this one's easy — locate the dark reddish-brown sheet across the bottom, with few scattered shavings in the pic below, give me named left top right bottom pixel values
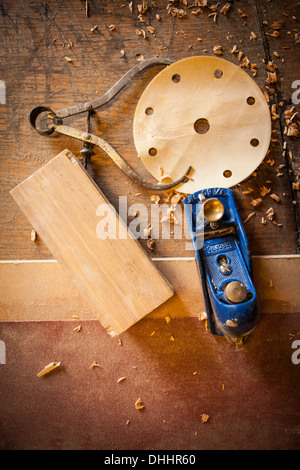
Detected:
left=0, top=314, right=300, bottom=450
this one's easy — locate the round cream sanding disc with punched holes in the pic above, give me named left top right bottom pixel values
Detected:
left=133, top=57, right=271, bottom=193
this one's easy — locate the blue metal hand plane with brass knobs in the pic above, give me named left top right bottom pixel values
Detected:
left=183, top=188, right=260, bottom=348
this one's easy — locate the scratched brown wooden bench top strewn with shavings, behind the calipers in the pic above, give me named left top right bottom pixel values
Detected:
left=0, top=0, right=300, bottom=259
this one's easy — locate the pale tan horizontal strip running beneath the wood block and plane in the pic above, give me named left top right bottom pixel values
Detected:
left=0, top=256, right=300, bottom=322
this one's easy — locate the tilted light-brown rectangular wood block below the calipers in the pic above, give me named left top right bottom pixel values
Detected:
left=11, top=150, right=173, bottom=335
